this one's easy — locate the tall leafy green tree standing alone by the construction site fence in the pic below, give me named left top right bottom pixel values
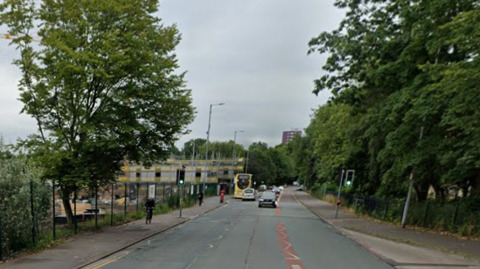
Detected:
left=0, top=0, right=194, bottom=220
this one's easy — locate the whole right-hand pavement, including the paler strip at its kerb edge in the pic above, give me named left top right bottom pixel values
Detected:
left=294, top=188, right=480, bottom=269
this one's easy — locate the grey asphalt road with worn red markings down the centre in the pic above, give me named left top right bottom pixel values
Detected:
left=88, top=189, right=391, bottom=269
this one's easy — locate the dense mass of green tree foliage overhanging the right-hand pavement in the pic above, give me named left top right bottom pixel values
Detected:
left=289, top=0, right=480, bottom=202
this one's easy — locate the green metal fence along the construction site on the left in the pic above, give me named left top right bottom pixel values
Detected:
left=0, top=182, right=218, bottom=260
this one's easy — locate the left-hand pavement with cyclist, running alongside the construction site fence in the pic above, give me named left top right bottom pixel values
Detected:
left=0, top=197, right=230, bottom=269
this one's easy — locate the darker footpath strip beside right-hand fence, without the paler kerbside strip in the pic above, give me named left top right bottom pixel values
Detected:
left=294, top=189, right=480, bottom=259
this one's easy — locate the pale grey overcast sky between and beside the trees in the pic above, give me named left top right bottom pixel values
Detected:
left=0, top=0, right=343, bottom=149
